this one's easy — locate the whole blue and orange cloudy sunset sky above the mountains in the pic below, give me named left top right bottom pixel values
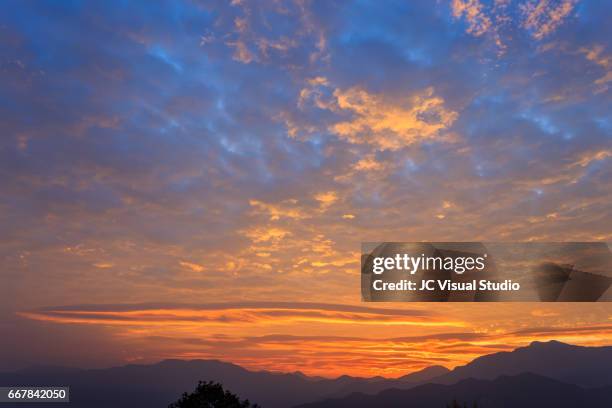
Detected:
left=0, top=0, right=612, bottom=377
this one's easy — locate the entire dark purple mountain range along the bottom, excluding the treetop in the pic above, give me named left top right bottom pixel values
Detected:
left=0, top=341, right=612, bottom=408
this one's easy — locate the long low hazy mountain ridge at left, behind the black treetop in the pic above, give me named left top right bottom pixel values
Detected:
left=0, top=360, right=440, bottom=408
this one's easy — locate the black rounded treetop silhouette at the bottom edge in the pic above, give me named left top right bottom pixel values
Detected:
left=168, top=381, right=260, bottom=408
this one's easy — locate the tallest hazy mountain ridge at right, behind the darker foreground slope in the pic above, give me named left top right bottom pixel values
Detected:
left=433, top=341, right=612, bottom=388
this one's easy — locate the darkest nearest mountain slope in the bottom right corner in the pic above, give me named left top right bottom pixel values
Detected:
left=296, top=373, right=612, bottom=408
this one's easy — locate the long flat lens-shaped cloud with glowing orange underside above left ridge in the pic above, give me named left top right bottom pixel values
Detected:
left=20, top=302, right=452, bottom=329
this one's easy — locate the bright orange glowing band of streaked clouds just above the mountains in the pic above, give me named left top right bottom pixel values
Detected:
left=21, top=302, right=612, bottom=377
